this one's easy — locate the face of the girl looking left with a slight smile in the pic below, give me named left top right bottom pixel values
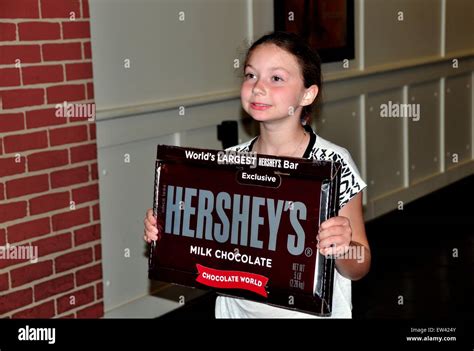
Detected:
left=240, top=44, right=317, bottom=122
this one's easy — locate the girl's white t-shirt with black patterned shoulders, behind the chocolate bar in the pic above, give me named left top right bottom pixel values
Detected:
left=215, top=125, right=367, bottom=318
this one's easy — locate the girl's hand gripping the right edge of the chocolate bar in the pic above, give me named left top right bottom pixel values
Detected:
left=316, top=216, right=352, bottom=257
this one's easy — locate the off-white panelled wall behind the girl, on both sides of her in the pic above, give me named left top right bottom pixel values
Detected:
left=90, top=0, right=474, bottom=316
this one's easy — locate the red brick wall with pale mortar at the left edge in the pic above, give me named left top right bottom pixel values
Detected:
left=0, top=0, right=103, bottom=318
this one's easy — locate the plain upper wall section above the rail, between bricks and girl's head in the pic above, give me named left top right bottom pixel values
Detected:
left=91, top=0, right=247, bottom=112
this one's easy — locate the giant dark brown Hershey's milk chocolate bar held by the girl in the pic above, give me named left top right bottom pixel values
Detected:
left=149, top=145, right=341, bottom=315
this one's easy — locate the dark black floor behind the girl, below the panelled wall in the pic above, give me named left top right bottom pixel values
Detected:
left=161, top=176, right=474, bottom=320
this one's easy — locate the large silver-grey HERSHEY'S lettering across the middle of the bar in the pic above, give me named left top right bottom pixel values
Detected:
left=165, top=185, right=307, bottom=256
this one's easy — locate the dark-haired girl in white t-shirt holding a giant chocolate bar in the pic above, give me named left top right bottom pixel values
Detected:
left=144, top=32, right=371, bottom=318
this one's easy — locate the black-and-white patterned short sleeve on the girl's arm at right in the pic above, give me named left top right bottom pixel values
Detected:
left=339, top=149, right=367, bottom=208
